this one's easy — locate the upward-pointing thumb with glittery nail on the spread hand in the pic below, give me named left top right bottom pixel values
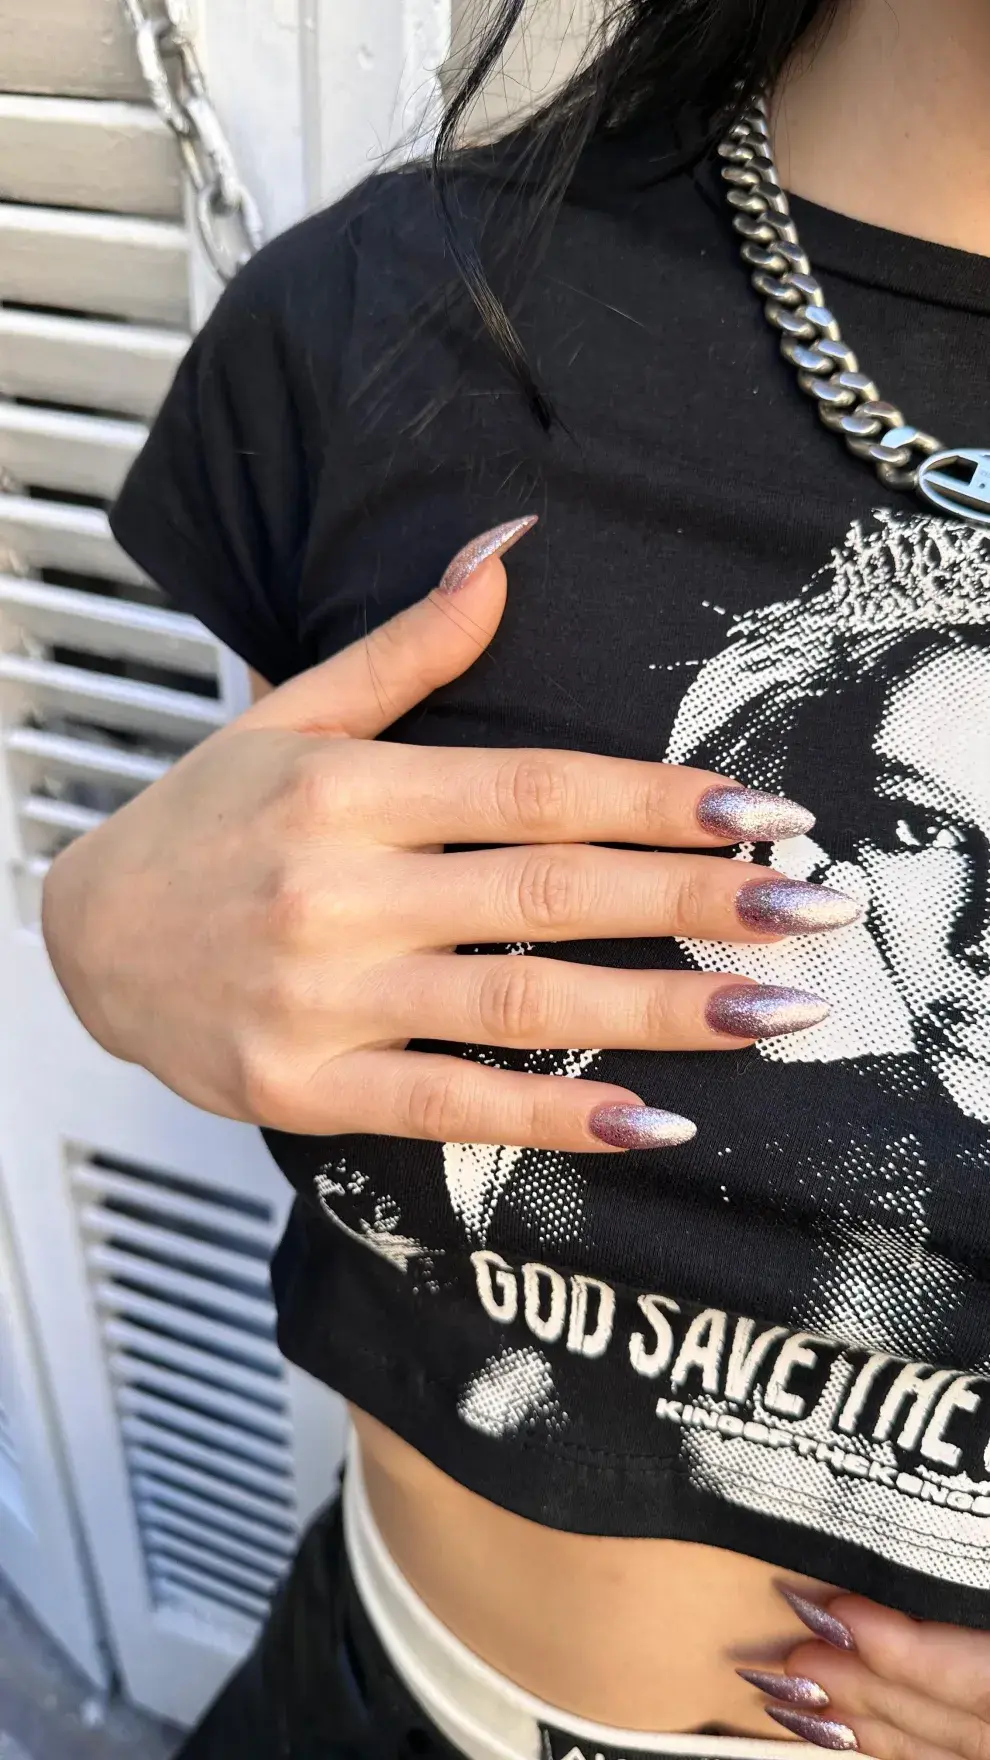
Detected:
left=234, top=514, right=537, bottom=739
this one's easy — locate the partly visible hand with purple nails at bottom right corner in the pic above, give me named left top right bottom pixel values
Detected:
left=740, top=1591, right=990, bottom=1760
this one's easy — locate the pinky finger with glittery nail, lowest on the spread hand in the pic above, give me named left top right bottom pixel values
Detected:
left=324, top=1051, right=696, bottom=1155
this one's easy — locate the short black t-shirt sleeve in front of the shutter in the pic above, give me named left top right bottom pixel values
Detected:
left=111, top=225, right=349, bottom=685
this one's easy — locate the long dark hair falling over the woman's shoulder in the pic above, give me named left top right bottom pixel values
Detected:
left=433, top=0, right=837, bottom=428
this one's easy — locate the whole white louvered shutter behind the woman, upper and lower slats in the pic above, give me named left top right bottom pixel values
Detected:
left=0, top=0, right=342, bottom=1721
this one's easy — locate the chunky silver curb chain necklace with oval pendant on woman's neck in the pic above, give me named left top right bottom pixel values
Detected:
left=719, top=99, right=990, bottom=526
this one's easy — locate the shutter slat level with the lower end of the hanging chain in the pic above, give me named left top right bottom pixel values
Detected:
left=0, top=202, right=188, bottom=327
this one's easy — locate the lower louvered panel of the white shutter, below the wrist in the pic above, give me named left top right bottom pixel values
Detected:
left=70, top=1153, right=298, bottom=1623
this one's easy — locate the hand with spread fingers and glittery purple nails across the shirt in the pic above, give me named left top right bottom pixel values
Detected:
left=44, top=521, right=860, bottom=1151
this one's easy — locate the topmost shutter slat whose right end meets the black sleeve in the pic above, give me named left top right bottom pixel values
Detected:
left=0, top=308, right=188, bottom=419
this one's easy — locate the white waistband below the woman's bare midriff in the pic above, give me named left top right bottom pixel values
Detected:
left=344, top=1443, right=821, bottom=1760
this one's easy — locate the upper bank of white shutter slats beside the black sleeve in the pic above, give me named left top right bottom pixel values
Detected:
left=0, top=75, right=225, bottom=924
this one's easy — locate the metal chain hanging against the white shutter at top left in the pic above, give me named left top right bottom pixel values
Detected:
left=122, top=0, right=262, bottom=282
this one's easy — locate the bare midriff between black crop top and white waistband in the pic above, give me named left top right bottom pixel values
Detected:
left=352, top=1410, right=821, bottom=1741
